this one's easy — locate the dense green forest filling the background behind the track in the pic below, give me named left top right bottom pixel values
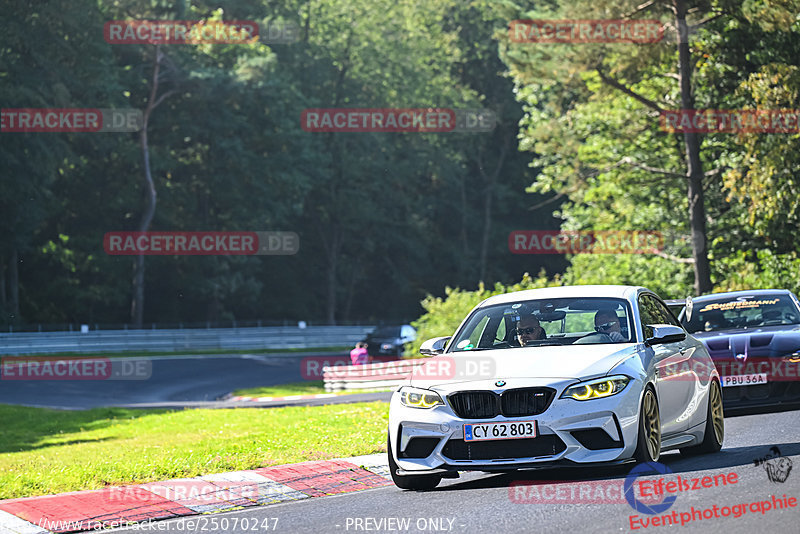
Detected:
left=0, top=0, right=800, bottom=330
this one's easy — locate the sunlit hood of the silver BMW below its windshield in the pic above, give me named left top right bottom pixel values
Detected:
left=409, top=343, right=637, bottom=388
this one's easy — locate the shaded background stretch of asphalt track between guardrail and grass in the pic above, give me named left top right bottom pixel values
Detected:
left=0, top=354, right=360, bottom=409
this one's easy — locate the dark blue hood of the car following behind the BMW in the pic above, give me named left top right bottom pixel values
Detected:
left=692, top=325, right=800, bottom=360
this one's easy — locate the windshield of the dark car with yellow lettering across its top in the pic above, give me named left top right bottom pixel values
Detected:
left=681, top=294, right=800, bottom=333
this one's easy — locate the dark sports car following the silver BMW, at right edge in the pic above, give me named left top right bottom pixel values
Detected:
left=679, top=289, right=800, bottom=409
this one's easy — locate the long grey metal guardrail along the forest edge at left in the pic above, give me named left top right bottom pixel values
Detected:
left=0, top=326, right=375, bottom=355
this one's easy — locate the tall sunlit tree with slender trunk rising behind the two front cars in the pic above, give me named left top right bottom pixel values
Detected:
left=502, top=0, right=791, bottom=294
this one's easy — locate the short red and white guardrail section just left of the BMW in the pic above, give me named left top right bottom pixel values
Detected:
left=322, top=358, right=427, bottom=391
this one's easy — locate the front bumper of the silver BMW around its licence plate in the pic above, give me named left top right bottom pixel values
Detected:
left=389, top=379, right=642, bottom=474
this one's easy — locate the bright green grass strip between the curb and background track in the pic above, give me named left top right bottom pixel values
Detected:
left=0, top=402, right=389, bottom=499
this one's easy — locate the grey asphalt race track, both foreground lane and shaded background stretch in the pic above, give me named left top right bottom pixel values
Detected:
left=0, top=355, right=800, bottom=534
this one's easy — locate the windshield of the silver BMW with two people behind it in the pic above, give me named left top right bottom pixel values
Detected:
left=452, top=298, right=633, bottom=352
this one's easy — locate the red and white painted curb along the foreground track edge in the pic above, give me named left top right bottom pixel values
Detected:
left=0, top=453, right=391, bottom=534
